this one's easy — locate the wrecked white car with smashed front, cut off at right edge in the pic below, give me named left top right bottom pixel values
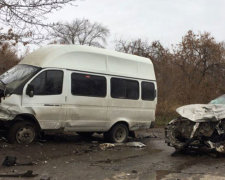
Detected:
left=165, top=95, right=225, bottom=153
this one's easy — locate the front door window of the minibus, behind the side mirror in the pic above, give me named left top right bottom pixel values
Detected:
left=30, top=70, right=63, bottom=95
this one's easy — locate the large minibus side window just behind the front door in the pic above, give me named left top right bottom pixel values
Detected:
left=71, top=73, right=106, bottom=97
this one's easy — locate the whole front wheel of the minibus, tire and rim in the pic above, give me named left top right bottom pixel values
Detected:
left=8, top=121, right=37, bottom=144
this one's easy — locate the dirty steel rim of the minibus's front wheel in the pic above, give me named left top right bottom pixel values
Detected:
left=16, top=127, right=35, bottom=144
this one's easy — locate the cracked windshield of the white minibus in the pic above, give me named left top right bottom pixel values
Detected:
left=0, top=64, right=39, bottom=93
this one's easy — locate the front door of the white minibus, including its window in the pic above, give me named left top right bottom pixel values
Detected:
left=22, top=69, right=66, bottom=129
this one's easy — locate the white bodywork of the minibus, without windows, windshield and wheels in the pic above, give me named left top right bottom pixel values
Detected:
left=0, top=45, right=157, bottom=132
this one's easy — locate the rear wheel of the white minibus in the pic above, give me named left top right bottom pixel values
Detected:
left=105, top=123, right=129, bottom=143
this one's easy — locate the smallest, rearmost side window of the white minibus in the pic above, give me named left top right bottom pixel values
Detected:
left=141, top=81, right=156, bottom=101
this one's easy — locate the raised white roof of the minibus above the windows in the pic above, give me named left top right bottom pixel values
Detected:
left=20, top=45, right=155, bottom=80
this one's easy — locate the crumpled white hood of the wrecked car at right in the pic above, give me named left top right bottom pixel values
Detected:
left=176, top=104, right=225, bottom=122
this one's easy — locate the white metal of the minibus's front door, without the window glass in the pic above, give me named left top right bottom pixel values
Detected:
left=22, top=68, right=67, bottom=129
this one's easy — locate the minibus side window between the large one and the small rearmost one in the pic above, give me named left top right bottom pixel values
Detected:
left=111, top=78, right=139, bottom=100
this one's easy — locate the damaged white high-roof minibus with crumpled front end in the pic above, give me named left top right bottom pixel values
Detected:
left=0, top=45, right=157, bottom=144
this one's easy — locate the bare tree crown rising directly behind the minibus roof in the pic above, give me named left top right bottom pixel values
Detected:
left=50, top=19, right=109, bottom=47
